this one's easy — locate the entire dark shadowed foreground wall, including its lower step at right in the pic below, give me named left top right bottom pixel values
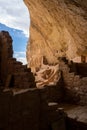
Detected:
left=0, top=88, right=65, bottom=130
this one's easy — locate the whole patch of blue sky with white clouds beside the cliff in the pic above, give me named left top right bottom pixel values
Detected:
left=0, top=0, right=30, bottom=64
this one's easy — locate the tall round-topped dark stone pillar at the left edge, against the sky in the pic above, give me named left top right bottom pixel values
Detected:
left=0, top=31, right=13, bottom=83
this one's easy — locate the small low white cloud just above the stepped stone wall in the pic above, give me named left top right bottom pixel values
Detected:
left=14, top=51, right=27, bottom=64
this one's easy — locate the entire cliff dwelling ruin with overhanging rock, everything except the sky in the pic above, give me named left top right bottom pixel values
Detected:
left=0, top=0, right=87, bottom=130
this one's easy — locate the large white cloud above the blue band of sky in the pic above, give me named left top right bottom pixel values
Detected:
left=0, top=0, right=30, bottom=37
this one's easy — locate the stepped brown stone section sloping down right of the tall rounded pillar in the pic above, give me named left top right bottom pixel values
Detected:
left=8, top=59, right=36, bottom=88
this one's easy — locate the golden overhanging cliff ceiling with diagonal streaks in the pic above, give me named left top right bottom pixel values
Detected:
left=24, top=0, right=87, bottom=87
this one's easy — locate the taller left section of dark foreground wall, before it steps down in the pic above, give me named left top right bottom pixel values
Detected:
left=0, top=89, right=47, bottom=130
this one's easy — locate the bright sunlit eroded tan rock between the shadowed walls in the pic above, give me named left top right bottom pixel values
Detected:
left=35, top=65, right=61, bottom=88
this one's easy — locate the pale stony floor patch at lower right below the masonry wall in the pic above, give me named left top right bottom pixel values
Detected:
left=59, top=104, right=87, bottom=124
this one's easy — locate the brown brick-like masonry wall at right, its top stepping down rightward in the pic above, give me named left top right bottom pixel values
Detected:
left=60, top=61, right=87, bottom=105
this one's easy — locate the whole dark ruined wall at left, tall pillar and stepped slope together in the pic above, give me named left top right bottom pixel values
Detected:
left=0, top=31, right=36, bottom=88
